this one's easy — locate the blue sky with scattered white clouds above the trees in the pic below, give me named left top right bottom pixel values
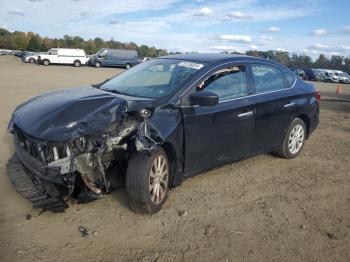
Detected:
left=0, top=0, right=350, bottom=57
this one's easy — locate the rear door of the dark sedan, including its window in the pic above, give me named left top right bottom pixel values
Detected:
left=251, top=63, right=297, bottom=153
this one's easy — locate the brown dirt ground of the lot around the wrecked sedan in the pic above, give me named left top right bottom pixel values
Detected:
left=0, top=57, right=350, bottom=261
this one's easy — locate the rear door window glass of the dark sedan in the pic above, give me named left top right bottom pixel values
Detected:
left=252, top=65, right=284, bottom=94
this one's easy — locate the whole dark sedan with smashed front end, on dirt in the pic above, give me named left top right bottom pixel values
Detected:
left=7, top=54, right=320, bottom=214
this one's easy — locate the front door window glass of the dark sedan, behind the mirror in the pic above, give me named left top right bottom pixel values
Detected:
left=197, top=65, right=248, bottom=101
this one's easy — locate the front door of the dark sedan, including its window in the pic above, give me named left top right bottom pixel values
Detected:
left=182, top=63, right=255, bottom=174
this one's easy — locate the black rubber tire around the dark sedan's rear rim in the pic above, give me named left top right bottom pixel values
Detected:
left=275, top=118, right=307, bottom=159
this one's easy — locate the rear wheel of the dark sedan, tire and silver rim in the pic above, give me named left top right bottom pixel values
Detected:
left=276, top=118, right=306, bottom=159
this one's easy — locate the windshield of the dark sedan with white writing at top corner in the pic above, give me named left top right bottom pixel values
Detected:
left=100, top=59, right=205, bottom=99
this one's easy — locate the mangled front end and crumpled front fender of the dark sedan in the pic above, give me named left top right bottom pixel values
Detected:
left=7, top=103, right=183, bottom=210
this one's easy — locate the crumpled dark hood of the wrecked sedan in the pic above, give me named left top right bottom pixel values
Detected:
left=10, top=87, right=152, bottom=141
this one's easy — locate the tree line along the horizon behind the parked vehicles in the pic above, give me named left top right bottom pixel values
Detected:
left=0, top=29, right=350, bottom=72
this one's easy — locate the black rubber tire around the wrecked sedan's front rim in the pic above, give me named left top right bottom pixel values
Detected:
left=126, top=148, right=171, bottom=215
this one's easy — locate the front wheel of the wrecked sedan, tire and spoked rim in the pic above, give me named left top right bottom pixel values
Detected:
left=126, top=148, right=170, bottom=214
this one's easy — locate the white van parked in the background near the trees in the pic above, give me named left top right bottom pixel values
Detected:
left=38, top=48, right=88, bottom=67
